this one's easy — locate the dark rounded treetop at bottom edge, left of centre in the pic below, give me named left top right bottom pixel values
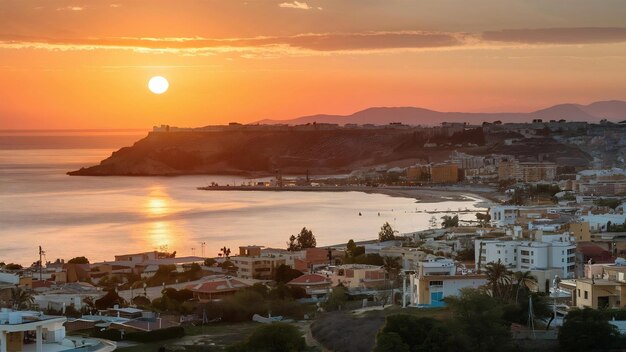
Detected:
left=227, top=323, right=306, bottom=352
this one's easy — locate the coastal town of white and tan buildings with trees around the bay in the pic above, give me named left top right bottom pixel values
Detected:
left=0, top=120, right=626, bottom=352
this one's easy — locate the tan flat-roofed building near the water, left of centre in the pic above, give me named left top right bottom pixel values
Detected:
left=230, top=246, right=287, bottom=280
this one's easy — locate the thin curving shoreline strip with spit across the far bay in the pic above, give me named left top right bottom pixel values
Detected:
left=198, top=186, right=499, bottom=207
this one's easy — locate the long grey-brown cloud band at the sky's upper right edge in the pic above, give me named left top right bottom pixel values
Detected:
left=482, top=27, right=626, bottom=44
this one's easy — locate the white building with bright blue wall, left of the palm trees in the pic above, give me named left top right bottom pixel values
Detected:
left=405, top=257, right=487, bottom=307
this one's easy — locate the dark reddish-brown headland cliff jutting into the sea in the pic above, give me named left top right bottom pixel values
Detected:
left=68, top=129, right=448, bottom=176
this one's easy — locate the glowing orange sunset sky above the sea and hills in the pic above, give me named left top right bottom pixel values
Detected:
left=0, top=0, right=626, bottom=129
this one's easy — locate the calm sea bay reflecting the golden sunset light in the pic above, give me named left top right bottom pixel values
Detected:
left=0, top=131, right=478, bottom=265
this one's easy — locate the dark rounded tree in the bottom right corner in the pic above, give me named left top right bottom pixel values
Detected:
left=559, top=308, right=624, bottom=352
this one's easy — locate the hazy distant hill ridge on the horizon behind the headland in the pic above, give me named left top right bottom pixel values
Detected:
left=256, top=100, right=626, bottom=125
